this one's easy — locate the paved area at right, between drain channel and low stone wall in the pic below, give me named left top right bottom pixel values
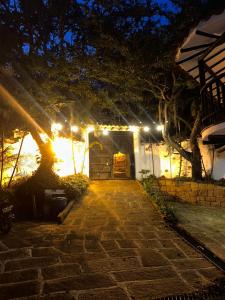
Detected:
left=173, top=202, right=225, bottom=261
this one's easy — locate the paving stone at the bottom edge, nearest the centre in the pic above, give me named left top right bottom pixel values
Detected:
left=78, top=288, right=129, bottom=300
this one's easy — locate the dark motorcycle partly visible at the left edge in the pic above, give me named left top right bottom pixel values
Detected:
left=0, top=199, right=15, bottom=234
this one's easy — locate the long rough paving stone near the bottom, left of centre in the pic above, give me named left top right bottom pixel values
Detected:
left=44, top=274, right=115, bottom=293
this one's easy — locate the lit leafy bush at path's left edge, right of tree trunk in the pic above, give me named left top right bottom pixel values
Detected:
left=60, top=174, right=89, bottom=200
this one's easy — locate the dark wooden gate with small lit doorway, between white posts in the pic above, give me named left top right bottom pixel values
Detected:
left=89, top=131, right=135, bottom=179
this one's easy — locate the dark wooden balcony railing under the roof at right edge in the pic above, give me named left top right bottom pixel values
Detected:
left=201, top=73, right=225, bottom=128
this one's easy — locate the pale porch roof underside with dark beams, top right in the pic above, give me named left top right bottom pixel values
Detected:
left=176, top=10, right=225, bottom=82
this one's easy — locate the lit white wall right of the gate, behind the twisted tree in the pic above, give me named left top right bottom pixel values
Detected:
left=134, top=133, right=225, bottom=180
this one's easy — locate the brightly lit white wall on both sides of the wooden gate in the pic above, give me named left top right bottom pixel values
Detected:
left=3, top=130, right=225, bottom=182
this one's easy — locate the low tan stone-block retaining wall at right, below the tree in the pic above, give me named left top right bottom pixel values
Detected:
left=159, top=179, right=225, bottom=207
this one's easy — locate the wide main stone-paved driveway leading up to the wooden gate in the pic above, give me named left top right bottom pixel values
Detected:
left=0, top=180, right=223, bottom=300
